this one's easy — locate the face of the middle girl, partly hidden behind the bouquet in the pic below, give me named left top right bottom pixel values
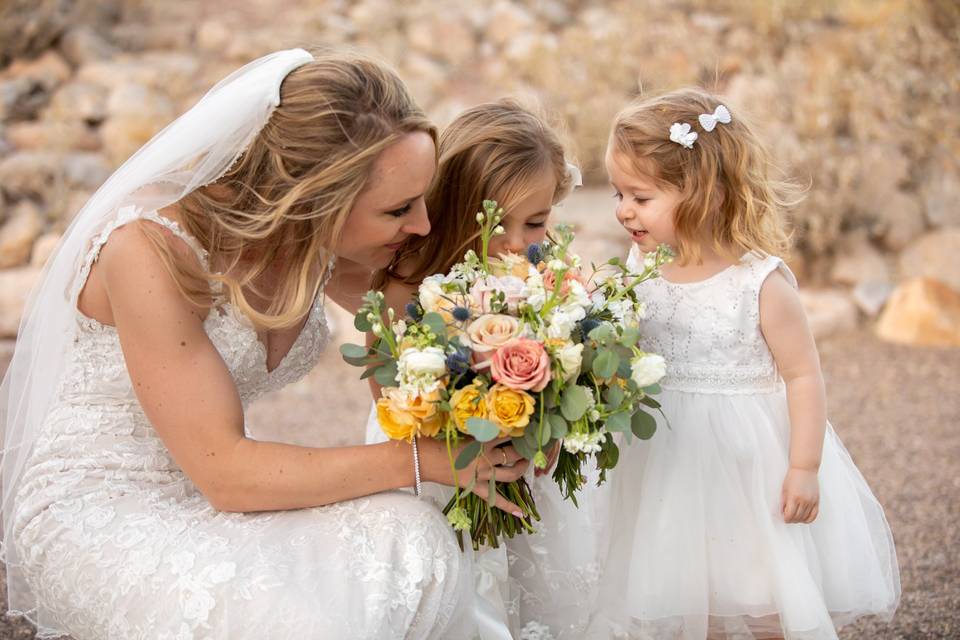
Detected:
left=489, top=167, right=557, bottom=256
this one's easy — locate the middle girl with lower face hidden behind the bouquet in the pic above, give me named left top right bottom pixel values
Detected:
left=367, top=100, right=598, bottom=638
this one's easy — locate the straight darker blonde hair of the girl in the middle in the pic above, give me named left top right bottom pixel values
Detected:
left=377, top=99, right=572, bottom=286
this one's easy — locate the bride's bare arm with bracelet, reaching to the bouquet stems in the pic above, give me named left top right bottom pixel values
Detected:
left=97, top=225, right=525, bottom=511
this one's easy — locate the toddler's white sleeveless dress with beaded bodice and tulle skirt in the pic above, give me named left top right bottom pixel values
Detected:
left=591, top=251, right=900, bottom=640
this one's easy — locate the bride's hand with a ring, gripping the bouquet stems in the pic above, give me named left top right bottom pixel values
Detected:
left=417, top=438, right=530, bottom=518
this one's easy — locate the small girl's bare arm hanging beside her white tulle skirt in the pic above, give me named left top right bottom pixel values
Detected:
left=760, top=271, right=827, bottom=523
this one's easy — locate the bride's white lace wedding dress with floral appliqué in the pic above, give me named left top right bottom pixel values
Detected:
left=12, top=207, right=475, bottom=640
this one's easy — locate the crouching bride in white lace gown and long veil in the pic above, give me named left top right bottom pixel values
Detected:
left=0, top=49, right=526, bottom=640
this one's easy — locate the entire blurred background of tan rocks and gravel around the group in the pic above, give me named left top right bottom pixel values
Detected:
left=0, top=0, right=960, bottom=638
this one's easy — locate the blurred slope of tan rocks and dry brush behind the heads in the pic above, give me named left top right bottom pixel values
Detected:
left=0, top=0, right=960, bottom=344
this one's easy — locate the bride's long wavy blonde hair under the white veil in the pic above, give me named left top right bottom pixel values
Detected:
left=144, top=52, right=437, bottom=329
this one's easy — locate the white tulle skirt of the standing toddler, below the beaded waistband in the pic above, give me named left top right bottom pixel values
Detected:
left=589, top=389, right=900, bottom=640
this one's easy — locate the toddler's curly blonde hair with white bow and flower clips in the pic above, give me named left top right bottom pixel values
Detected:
left=609, top=89, right=798, bottom=264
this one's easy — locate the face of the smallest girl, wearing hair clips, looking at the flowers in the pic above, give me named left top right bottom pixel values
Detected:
left=604, top=150, right=681, bottom=253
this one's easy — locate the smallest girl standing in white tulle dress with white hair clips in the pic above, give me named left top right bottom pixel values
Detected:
left=591, top=90, right=900, bottom=640
